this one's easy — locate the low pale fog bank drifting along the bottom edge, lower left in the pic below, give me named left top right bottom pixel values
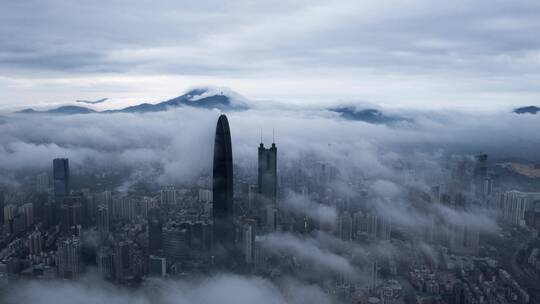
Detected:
left=0, top=274, right=332, bottom=304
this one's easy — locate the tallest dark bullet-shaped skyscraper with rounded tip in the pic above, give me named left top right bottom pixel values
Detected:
left=212, top=115, right=235, bottom=247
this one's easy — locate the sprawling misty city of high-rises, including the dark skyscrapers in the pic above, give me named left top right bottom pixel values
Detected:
left=0, top=107, right=540, bottom=303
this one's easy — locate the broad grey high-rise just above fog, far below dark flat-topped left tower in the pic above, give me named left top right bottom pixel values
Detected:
left=56, top=237, right=81, bottom=279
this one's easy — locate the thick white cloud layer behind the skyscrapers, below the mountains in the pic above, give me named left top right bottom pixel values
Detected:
left=0, top=107, right=540, bottom=183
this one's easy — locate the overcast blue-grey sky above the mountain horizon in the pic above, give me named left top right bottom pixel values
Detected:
left=0, top=0, right=540, bottom=110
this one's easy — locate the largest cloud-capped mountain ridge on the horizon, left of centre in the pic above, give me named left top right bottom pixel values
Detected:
left=17, top=88, right=248, bottom=114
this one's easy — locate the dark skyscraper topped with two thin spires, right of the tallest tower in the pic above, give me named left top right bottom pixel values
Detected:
left=258, top=143, right=277, bottom=206
